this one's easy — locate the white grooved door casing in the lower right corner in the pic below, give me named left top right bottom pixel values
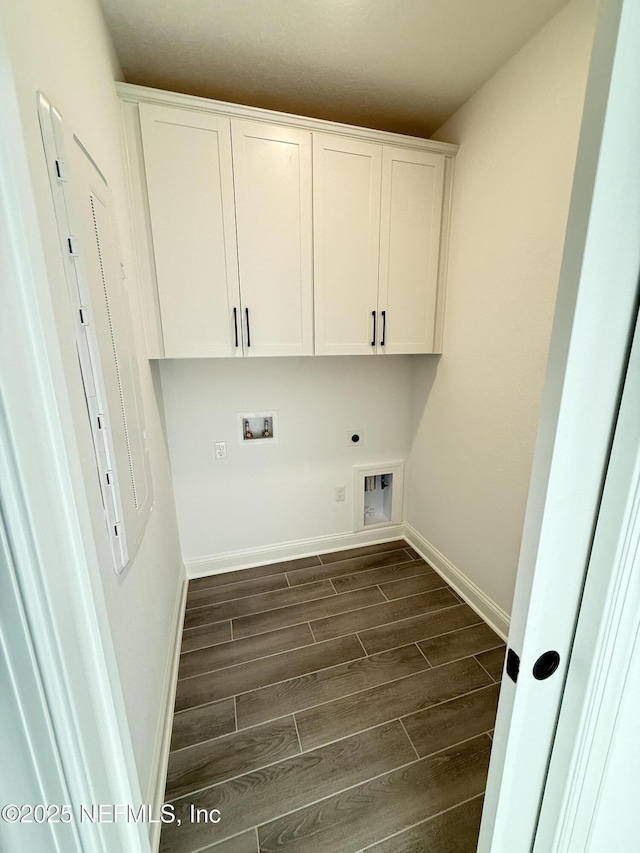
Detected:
left=534, top=278, right=640, bottom=853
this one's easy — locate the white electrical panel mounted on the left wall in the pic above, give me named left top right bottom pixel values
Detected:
left=38, top=93, right=153, bottom=574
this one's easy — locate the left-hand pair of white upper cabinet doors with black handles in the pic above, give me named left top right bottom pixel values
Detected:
left=140, top=109, right=313, bottom=358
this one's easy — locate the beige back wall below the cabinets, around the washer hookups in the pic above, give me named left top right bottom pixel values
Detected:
left=160, top=356, right=412, bottom=561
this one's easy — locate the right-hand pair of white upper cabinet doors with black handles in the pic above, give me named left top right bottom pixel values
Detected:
left=313, top=134, right=445, bottom=355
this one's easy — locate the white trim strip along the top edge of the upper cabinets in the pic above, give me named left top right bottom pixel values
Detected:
left=116, top=82, right=459, bottom=157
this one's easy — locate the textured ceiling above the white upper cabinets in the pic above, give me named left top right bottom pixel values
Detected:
left=101, top=0, right=567, bottom=136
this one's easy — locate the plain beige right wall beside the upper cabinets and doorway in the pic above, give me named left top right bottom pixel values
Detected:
left=407, top=0, right=594, bottom=613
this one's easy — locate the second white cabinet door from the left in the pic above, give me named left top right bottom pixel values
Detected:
left=231, top=120, right=313, bottom=356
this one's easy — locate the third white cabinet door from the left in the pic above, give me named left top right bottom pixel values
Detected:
left=313, top=134, right=382, bottom=355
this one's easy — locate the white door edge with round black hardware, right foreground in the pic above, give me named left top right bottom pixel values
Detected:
left=478, top=0, right=640, bottom=853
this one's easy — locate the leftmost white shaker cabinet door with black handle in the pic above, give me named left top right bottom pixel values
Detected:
left=140, top=104, right=242, bottom=358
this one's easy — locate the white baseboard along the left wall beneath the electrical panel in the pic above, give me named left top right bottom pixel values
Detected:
left=145, top=564, right=187, bottom=853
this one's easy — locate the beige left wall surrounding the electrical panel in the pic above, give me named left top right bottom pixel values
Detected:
left=0, top=0, right=183, bottom=802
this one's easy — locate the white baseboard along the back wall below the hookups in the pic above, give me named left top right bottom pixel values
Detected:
left=185, top=524, right=404, bottom=578
